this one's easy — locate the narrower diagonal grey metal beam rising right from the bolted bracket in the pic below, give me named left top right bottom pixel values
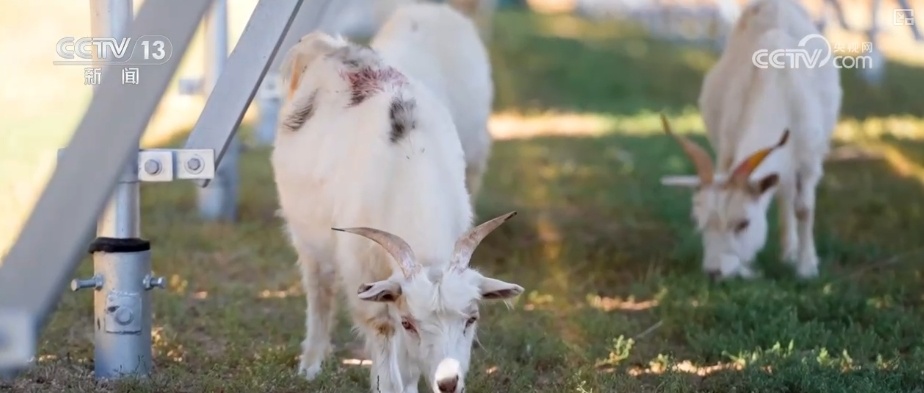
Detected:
left=184, top=0, right=304, bottom=187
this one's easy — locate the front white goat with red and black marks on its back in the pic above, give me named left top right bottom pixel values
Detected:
left=271, top=32, right=523, bottom=392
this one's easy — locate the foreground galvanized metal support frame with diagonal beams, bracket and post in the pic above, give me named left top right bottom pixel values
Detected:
left=0, top=0, right=303, bottom=378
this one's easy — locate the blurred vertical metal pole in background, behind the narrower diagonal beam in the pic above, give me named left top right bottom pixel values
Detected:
left=198, top=0, right=241, bottom=221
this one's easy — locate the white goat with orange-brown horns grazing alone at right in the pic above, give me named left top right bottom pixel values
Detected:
left=662, top=0, right=842, bottom=278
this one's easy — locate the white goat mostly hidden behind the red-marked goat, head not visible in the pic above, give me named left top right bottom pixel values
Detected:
left=369, top=3, right=494, bottom=206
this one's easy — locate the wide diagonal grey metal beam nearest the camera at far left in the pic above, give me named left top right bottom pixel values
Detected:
left=0, top=0, right=210, bottom=374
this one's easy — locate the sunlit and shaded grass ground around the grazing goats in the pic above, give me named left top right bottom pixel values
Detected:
left=9, top=7, right=924, bottom=393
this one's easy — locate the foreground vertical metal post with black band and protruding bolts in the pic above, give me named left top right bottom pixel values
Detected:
left=71, top=0, right=163, bottom=378
